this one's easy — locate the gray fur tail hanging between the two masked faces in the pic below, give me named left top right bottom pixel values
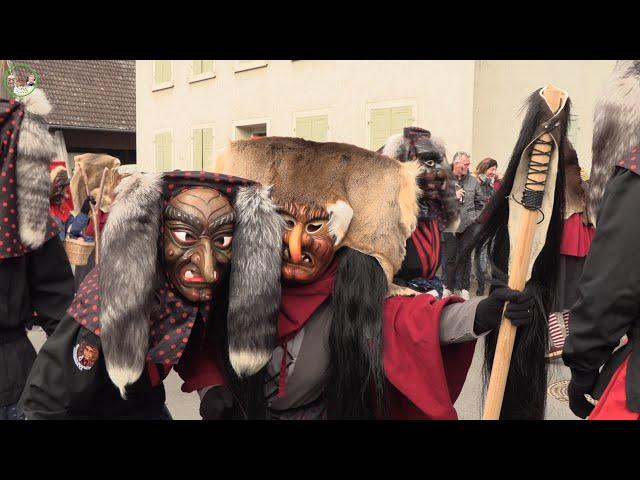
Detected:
left=227, top=186, right=284, bottom=377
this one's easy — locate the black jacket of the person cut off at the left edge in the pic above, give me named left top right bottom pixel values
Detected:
left=0, top=236, right=74, bottom=406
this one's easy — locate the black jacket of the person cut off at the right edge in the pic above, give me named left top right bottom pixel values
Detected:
left=562, top=168, right=640, bottom=411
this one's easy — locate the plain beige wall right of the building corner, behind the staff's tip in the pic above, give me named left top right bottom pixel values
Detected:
left=471, top=60, right=615, bottom=172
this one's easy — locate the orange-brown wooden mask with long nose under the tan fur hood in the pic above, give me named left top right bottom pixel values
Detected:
left=278, top=202, right=335, bottom=284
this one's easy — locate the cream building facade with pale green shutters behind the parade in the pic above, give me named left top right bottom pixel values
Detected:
left=136, top=60, right=615, bottom=175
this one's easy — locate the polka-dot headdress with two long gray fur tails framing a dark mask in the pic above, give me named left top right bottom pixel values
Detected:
left=99, top=171, right=283, bottom=392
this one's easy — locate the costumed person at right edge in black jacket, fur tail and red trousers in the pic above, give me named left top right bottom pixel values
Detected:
left=562, top=60, right=640, bottom=420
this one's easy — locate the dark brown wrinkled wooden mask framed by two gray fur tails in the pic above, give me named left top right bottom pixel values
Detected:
left=162, top=188, right=235, bottom=302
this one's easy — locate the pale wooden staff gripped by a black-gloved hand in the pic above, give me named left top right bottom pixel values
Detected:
left=482, top=85, right=562, bottom=420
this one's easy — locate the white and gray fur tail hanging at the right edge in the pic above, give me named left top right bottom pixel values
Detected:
left=586, top=60, right=640, bottom=225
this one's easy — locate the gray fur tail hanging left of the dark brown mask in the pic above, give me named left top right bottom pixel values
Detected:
left=100, top=173, right=162, bottom=398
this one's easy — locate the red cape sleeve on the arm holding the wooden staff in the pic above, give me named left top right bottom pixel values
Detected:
left=384, top=294, right=475, bottom=420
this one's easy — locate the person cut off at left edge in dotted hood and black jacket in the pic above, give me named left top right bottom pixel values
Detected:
left=0, top=90, right=73, bottom=420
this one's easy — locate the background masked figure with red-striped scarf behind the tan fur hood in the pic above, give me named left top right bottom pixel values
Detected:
left=378, top=127, right=460, bottom=297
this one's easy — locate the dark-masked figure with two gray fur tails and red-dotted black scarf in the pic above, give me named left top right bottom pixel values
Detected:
left=20, top=171, right=282, bottom=419
